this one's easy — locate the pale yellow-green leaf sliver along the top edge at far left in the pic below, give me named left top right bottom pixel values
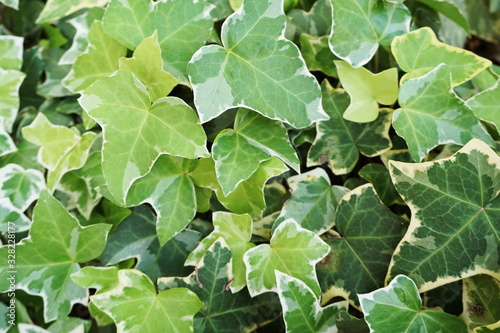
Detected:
left=35, top=0, right=109, bottom=24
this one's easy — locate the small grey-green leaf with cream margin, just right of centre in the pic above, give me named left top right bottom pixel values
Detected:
left=273, top=168, right=348, bottom=235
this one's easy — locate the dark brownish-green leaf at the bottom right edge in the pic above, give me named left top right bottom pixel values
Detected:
left=461, top=274, right=500, bottom=329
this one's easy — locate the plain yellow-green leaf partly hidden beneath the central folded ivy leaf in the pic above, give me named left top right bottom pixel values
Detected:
left=215, top=157, right=288, bottom=219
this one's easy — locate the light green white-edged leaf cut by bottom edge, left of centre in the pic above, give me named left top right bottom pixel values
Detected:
left=90, top=270, right=203, bottom=333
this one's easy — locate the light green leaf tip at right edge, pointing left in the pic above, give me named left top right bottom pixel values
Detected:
left=465, top=80, right=500, bottom=133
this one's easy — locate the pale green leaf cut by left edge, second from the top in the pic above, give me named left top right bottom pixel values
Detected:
left=0, top=68, right=26, bottom=133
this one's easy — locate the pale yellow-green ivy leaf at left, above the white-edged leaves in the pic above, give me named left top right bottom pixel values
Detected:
left=22, top=113, right=96, bottom=191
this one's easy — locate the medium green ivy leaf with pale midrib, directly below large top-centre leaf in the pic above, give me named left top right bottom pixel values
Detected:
left=212, top=108, right=300, bottom=195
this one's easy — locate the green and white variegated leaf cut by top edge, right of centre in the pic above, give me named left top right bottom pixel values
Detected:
left=330, top=0, right=411, bottom=68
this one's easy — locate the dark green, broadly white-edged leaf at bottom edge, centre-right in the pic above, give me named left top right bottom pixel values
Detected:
left=276, top=271, right=348, bottom=333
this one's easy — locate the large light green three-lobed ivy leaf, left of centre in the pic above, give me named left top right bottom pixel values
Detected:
left=78, top=70, right=208, bottom=204
